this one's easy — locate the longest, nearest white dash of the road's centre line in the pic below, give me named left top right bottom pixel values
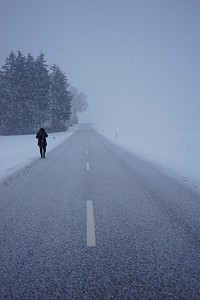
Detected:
left=87, top=200, right=96, bottom=247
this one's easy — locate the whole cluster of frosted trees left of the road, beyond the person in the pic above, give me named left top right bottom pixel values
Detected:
left=0, top=51, right=89, bottom=135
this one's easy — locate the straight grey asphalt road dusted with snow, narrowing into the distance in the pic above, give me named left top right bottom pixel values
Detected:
left=0, top=125, right=200, bottom=300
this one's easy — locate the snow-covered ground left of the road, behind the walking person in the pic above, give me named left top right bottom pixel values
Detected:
left=0, top=127, right=76, bottom=180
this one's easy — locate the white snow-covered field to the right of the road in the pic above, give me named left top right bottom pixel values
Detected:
left=94, top=123, right=200, bottom=192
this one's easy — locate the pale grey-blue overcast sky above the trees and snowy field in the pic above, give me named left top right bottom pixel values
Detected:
left=0, top=0, right=200, bottom=130
